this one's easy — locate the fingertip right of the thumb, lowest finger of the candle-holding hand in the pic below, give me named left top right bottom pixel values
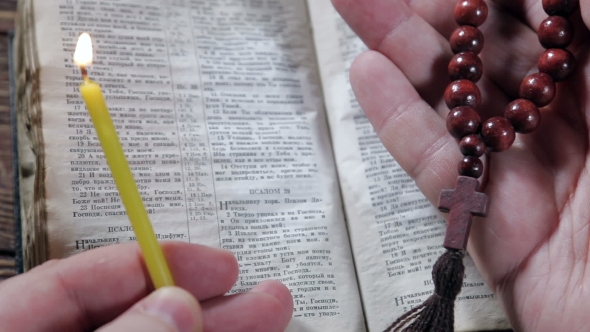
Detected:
left=201, top=280, right=293, bottom=332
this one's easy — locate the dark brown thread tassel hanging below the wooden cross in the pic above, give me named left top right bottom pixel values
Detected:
left=384, top=249, right=465, bottom=332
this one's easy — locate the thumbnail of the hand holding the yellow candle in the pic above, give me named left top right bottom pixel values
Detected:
left=137, top=287, right=201, bottom=332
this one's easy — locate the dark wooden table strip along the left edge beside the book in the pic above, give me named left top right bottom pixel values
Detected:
left=0, top=0, right=17, bottom=280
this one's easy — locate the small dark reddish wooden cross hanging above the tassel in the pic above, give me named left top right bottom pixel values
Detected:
left=438, top=176, right=489, bottom=250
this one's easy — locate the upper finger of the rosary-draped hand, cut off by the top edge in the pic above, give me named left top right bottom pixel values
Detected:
left=333, top=0, right=508, bottom=117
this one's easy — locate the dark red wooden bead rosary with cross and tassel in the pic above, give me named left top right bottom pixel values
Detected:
left=385, top=0, right=578, bottom=332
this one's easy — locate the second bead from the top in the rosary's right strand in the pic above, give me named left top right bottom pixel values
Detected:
left=537, top=16, right=574, bottom=48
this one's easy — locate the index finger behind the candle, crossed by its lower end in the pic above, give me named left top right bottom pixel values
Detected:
left=0, top=242, right=238, bottom=331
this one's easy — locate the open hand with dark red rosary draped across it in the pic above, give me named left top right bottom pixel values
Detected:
left=333, top=0, right=590, bottom=331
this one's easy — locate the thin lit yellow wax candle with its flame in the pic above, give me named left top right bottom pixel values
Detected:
left=74, top=34, right=174, bottom=288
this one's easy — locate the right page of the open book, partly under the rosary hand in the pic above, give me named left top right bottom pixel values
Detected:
left=309, top=0, right=508, bottom=331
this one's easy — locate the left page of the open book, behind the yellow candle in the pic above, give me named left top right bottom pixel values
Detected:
left=28, top=0, right=365, bottom=331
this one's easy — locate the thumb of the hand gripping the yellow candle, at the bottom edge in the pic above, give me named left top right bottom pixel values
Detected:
left=98, top=287, right=203, bottom=332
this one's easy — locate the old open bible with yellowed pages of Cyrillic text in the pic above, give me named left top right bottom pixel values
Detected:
left=15, top=0, right=509, bottom=331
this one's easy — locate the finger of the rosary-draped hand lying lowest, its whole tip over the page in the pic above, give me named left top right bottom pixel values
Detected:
left=351, top=51, right=460, bottom=201
